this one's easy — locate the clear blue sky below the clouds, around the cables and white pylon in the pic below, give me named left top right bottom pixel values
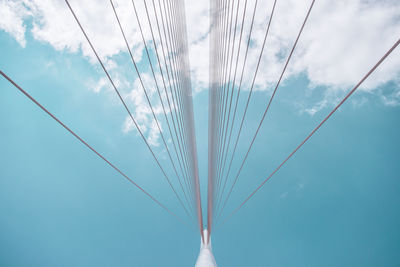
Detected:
left=0, top=1, right=400, bottom=266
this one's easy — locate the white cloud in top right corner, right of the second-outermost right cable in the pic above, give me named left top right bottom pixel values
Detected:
left=292, top=1, right=400, bottom=91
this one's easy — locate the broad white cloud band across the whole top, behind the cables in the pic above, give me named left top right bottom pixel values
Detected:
left=0, top=0, right=400, bottom=116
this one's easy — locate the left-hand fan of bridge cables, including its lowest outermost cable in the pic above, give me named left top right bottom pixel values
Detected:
left=1, top=0, right=203, bottom=232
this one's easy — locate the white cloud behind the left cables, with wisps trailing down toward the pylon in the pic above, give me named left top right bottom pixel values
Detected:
left=0, top=0, right=176, bottom=146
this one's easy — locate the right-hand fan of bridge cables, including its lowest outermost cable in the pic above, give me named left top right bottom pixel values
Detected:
left=207, top=0, right=398, bottom=234
